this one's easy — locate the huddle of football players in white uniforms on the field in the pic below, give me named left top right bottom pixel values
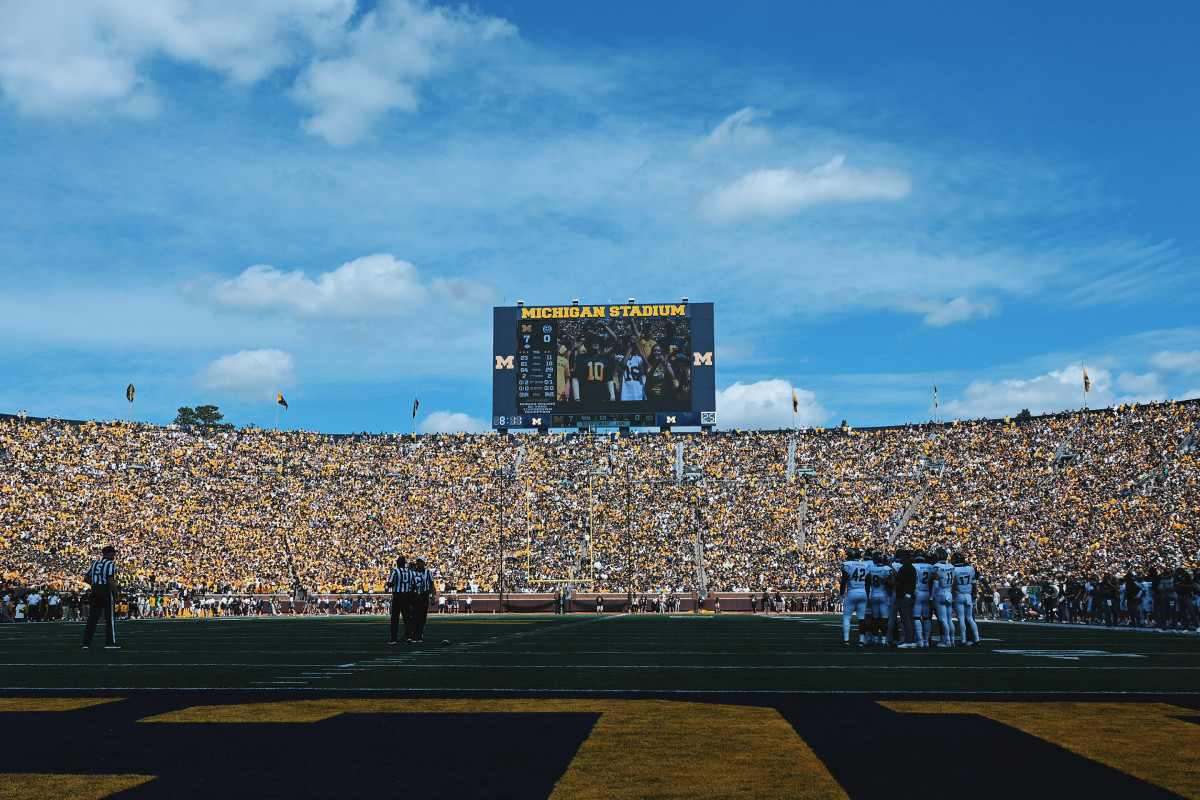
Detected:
left=839, top=548, right=979, bottom=648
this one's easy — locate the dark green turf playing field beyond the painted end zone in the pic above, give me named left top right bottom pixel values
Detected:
left=0, top=614, right=1200, bottom=693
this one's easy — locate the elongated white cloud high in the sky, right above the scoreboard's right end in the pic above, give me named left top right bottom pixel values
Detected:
left=700, top=156, right=912, bottom=224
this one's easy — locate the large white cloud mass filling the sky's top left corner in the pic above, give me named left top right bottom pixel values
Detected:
left=0, top=0, right=514, bottom=145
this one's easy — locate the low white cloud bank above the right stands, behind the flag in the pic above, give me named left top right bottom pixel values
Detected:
left=930, top=363, right=1165, bottom=419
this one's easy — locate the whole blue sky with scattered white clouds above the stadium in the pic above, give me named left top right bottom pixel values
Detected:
left=0, top=0, right=1200, bottom=432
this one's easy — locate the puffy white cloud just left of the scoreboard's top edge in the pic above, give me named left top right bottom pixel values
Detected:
left=208, top=253, right=491, bottom=319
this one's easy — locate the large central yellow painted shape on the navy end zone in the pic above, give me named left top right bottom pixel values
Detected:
left=142, top=698, right=847, bottom=800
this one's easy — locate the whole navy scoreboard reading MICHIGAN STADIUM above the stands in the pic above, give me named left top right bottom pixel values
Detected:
left=492, top=301, right=716, bottom=429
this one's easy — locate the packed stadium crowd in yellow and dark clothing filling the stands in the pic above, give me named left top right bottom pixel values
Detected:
left=0, top=401, right=1200, bottom=616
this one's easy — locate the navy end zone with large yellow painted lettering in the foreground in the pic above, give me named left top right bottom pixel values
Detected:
left=0, top=691, right=1200, bottom=800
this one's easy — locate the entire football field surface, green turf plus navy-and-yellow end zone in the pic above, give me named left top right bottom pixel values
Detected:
left=0, top=614, right=1200, bottom=800
